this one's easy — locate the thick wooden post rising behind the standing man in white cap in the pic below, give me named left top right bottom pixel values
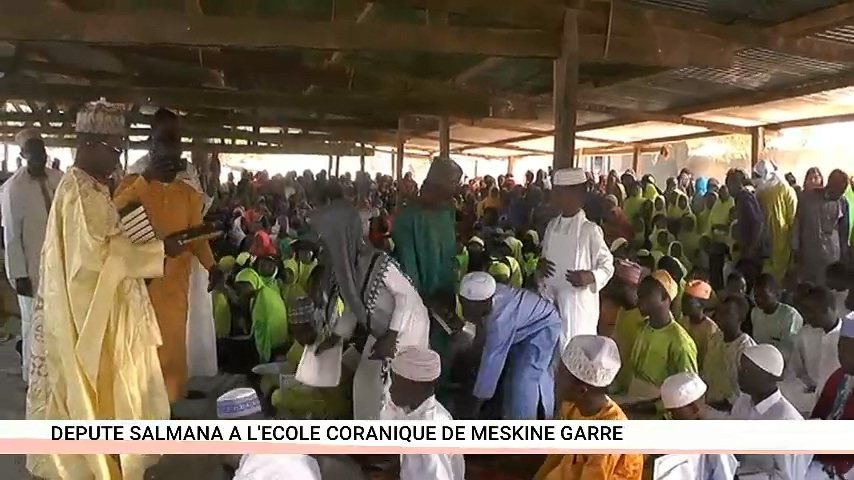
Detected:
left=553, top=9, right=578, bottom=169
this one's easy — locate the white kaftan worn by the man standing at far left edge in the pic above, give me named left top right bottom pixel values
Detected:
left=0, top=167, right=62, bottom=382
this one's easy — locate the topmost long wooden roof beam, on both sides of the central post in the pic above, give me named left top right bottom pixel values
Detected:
left=0, top=11, right=732, bottom=66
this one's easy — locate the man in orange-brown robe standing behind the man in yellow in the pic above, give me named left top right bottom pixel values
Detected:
left=113, top=109, right=215, bottom=402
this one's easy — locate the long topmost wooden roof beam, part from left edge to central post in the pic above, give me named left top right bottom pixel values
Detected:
left=0, top=9, right=558, bottom=57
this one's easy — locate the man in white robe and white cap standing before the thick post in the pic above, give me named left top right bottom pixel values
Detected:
left=538, top=168, right=614, bottom=351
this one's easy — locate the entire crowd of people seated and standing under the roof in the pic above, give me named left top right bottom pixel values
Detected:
left=0, top=98, right=854, bottom=480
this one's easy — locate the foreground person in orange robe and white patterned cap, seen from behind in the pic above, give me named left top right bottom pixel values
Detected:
left=534, top=335, right=643, bottom=480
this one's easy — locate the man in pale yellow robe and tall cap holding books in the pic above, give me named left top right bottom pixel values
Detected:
left=26, top=103, right=176, bottom=480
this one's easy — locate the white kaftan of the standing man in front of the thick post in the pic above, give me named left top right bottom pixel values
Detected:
left=540, top=210, right=614, bottom=351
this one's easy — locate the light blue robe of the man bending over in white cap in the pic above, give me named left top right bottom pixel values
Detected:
left=472, top=285, right=561, bottom=420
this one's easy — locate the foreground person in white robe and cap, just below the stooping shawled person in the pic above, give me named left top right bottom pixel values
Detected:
left=381, top=347, right=465, bottom=480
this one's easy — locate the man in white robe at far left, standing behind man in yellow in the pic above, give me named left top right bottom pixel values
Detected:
left=0, top=130, right=62, bottom=382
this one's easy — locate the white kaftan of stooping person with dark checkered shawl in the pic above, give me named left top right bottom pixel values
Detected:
left=353, top=263, right=430, bottom=420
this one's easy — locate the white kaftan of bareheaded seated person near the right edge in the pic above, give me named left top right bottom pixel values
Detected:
left=780, top=322, right=842, bottom=414
